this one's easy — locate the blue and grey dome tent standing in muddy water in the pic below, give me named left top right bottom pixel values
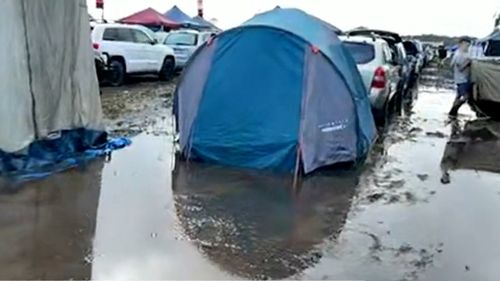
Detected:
left=174, top=9, right=376, bottom=173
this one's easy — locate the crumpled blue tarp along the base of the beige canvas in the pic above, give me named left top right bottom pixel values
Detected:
left=0, top=129, right=131, bottom=181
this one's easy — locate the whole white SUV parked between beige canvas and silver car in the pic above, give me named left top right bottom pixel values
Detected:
left=92, top=24, right=176, bottom=86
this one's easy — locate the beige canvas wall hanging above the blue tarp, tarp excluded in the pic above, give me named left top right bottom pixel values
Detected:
left=0, top=0, right=104, bottom=152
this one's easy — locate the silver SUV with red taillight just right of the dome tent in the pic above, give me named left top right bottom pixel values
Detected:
left=340, top=36, right=401, bottom=125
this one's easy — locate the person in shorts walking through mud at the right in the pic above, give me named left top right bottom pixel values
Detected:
left=449, top=38, right=472, bottom=117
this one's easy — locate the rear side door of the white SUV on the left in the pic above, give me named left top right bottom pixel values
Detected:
left=118, top=27, right=147, bottom=72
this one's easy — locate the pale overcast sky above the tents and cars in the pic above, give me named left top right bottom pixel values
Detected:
left=87, top=0, right=500, bottom=37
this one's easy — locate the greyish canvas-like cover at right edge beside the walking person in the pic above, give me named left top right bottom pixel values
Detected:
left=471, top=59, right=500, bottom=117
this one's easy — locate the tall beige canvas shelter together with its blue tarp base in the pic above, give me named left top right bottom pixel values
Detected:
left=0, top=0, right=129, bottom=179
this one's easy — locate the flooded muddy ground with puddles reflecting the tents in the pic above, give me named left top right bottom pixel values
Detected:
left=0, top=67, right=500, bottom=281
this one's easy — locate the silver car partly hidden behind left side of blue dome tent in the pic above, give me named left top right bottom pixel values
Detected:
left=163, top=29, right=214, bottom=69
